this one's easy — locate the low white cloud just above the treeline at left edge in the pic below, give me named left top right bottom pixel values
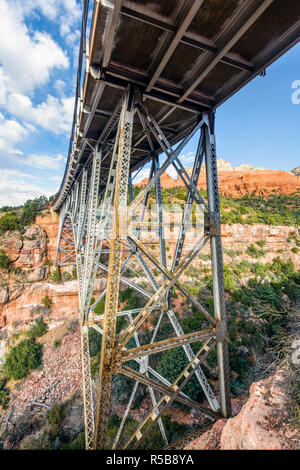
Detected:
left=0, top=168, right=53, bottom=207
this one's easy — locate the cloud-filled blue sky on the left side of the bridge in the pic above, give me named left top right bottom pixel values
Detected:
left=0, top=0, right=81, bottom=207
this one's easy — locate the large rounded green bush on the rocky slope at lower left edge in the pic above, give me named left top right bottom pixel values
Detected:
left=4, top=339, right=42, bottom=380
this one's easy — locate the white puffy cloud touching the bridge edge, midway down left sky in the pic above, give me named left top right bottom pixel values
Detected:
left=6, top=93, right=74, bottom=134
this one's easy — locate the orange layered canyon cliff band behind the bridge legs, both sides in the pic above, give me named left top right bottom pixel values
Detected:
left=0, top=213, right=300, bottom=328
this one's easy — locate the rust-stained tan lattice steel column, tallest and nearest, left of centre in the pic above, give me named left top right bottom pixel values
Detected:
left=94, top=93, right=134, bottom=449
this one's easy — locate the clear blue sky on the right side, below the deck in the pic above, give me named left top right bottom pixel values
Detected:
left=172, top=39, right=300, bottom=174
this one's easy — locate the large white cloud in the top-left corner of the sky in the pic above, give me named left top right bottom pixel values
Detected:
left=0, top=0, right=69, bottom=93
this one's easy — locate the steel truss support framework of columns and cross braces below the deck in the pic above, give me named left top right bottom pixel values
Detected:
left=57, top=88, right=231, bottom=449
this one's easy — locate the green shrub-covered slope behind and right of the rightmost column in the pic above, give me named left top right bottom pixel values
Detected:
left=157, top=253, right=300, bottom=400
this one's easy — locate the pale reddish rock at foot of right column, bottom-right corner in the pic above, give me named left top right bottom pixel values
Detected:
left=185, top=371, right=300, bottom=450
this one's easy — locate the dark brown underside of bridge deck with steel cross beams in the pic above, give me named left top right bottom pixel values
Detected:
left=55, top=0, right=300, bottom=210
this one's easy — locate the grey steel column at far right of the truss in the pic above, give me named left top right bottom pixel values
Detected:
left=203, top=114, right=231, bottom=418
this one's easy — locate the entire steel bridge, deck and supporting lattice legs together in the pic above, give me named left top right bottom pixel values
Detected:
left=53, top=0, right=300, bottom=449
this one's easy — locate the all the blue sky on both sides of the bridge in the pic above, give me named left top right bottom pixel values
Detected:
left=0, top=0, right=300, bottom=207
